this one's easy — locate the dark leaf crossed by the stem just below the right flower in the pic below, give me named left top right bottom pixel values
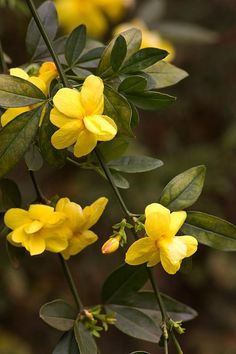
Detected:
left=116, top=291, right=197, bottom=322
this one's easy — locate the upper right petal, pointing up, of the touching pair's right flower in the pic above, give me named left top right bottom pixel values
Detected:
left=83, top=197, right=108, bottom=229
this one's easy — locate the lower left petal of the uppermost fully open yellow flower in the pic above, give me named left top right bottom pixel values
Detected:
left=51, top=120, right=82, bottom=149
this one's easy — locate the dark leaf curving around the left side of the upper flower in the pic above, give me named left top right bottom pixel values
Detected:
left=39, top=107, right=67, bottom=168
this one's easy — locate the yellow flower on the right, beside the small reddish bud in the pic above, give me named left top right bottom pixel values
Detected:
left=125, top=203, right=198, bottom=274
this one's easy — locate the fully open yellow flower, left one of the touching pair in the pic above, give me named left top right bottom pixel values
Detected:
left=4, top=204, right=71, bottom=256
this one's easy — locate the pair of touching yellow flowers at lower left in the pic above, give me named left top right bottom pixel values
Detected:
left=4, top=197, right=108, bottom=259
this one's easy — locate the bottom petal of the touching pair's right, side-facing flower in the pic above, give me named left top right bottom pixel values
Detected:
left=62, top=230, right=98, bottom=259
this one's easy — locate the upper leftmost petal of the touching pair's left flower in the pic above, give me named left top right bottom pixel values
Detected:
left=4, top=208, right=32, bottom=230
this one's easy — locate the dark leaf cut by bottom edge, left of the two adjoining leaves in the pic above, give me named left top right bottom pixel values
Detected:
left=52, top=330, right=80, bottom=354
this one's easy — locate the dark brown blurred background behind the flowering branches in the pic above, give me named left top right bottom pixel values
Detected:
left=0, top=0, right=236, bottom=354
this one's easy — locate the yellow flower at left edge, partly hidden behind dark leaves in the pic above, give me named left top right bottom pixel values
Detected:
left=1, top=62, right=57, bottom=127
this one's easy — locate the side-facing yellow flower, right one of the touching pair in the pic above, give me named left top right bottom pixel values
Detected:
left=56, top=197, right=108, bottom=259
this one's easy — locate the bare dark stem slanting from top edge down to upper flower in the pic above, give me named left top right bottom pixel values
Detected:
left=26, top=0, right=70, bottom=87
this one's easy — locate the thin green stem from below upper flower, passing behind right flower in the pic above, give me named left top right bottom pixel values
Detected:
left=95, top=148, right=168, bottom=354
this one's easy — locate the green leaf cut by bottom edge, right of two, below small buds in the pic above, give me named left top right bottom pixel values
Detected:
left=74, top=320, right=97, bottom=354
